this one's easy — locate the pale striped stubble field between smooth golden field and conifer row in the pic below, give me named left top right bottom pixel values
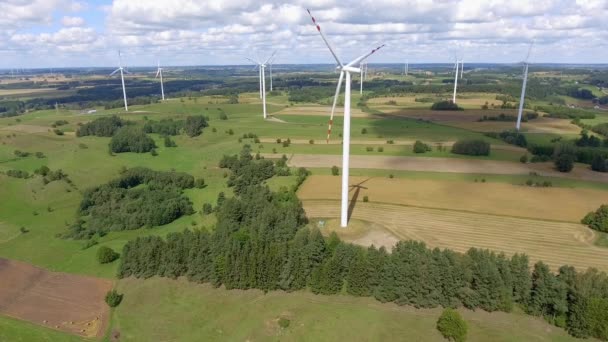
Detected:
left=303, top=200, right=608, bottom=271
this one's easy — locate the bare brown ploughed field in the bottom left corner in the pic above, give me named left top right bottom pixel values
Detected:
left=0, top=258, right=112, bottom=337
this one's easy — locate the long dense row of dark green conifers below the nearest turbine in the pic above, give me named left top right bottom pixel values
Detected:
left=118, top=184, right=608, bottom=339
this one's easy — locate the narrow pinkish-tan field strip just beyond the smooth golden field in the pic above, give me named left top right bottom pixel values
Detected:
left=284, top=154, right=608, bottom=183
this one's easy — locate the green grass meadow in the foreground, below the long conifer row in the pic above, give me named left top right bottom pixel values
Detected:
left=111, top=278, right=573, bottom=341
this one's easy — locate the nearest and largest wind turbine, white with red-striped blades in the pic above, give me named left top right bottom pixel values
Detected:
left=307, top=10, right=384, bottom=228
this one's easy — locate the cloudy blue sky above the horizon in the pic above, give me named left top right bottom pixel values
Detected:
left=0, top=0, right=608, bottom=69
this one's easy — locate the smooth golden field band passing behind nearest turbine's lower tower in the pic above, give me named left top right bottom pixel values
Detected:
left=298, top=175, right=608, bottom=222
